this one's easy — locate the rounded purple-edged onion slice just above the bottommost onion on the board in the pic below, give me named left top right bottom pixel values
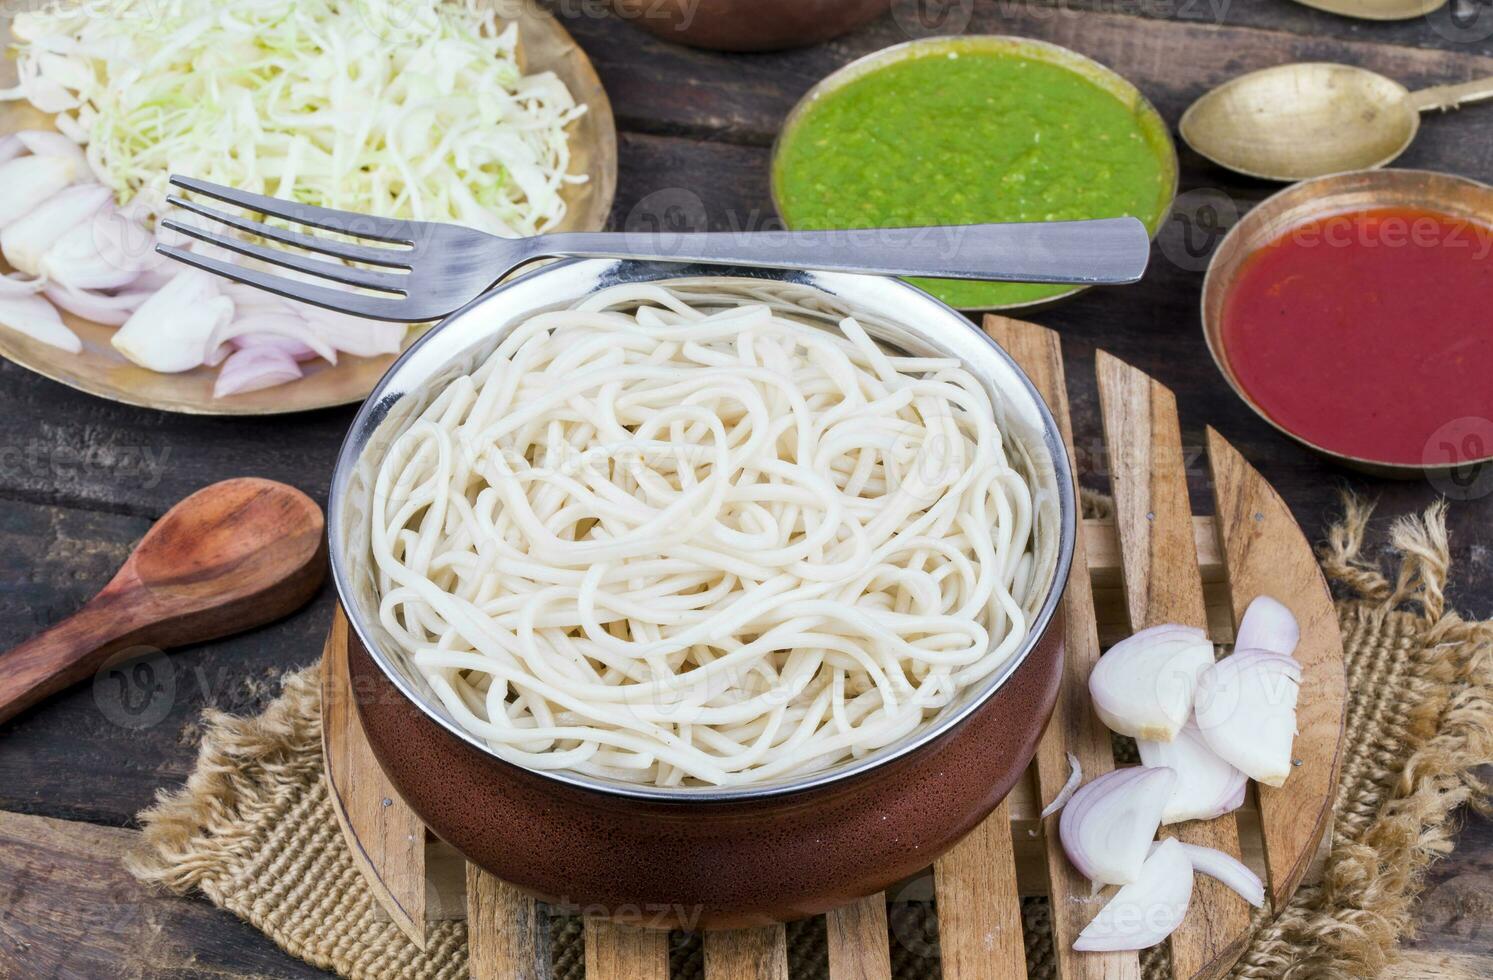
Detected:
left=1059, top=766, right=1176, bottom=884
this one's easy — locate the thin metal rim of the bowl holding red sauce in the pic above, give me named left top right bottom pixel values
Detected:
left=1197, top=167, right=1493, bottom=477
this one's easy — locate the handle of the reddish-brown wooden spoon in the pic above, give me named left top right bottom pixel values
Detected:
left=0, top=589, right=142, bottom=722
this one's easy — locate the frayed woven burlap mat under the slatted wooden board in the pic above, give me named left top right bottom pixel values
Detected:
left=130, top=502, right=1493, bottom=980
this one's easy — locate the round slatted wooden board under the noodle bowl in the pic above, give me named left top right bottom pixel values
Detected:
left=322, top=317, right=1345, bottom=980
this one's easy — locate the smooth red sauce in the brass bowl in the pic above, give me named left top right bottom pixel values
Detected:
left=1223, top=208, right=1493, bottom=465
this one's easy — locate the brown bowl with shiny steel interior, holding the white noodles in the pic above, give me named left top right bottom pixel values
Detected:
left=328, top=260, right=1076, bottom=928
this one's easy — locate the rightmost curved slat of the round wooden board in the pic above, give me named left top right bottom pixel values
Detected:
left=1208, top=429, right=1347, bottom=908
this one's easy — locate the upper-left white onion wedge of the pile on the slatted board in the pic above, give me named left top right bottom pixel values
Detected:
left=1088, top=626, right=1214, bottom=741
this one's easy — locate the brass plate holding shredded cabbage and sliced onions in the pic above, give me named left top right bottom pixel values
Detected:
left=0, top=0, right=617, bottom=415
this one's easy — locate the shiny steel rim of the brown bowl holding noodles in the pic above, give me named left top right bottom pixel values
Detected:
left=327, top=258, right=1078, bottom=804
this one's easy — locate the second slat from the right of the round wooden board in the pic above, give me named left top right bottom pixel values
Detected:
left=1097, top=351, right=1250, bottom=980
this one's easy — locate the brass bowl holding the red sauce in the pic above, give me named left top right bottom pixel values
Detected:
left=1202, top=169, right=1493, bottom=480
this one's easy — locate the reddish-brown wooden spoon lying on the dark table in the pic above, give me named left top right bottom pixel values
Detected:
left=0, top=478, right=327, bottom=722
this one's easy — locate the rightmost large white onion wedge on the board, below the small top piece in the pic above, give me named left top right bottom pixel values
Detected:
left=1196, top=650, right=1302, bottom=786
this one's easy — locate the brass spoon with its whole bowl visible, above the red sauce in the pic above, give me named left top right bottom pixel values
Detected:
left=1178, top=63, right=1493, bottom=181
